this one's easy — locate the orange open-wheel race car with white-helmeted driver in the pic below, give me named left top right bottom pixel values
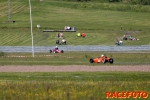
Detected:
left=90, top=54, right=114, bottom=64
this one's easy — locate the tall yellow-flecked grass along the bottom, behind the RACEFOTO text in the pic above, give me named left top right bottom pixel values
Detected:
left=0, top=81, right=149, bottom=100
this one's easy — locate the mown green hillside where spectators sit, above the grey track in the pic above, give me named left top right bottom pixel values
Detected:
left=0, top=0, right=150, bottom=46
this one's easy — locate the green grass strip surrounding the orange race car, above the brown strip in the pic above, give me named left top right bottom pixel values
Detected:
left=0, top=52, right=150, bottom=66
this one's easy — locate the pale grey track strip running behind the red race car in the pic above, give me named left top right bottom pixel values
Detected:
left=0, top=45, right=150, bottom=52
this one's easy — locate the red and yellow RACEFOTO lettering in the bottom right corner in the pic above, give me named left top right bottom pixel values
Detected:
left=106, top=91, right=148, bottom=99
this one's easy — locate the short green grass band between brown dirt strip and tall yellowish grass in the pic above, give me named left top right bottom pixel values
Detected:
left=0, top=72, right=150, bottom=82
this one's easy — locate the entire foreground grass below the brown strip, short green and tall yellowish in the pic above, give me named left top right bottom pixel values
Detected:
left=0, top=72, right=150, bottom=100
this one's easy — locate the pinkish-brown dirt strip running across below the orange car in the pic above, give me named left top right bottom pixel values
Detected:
left=0, top=65, right=150, bottom=72
